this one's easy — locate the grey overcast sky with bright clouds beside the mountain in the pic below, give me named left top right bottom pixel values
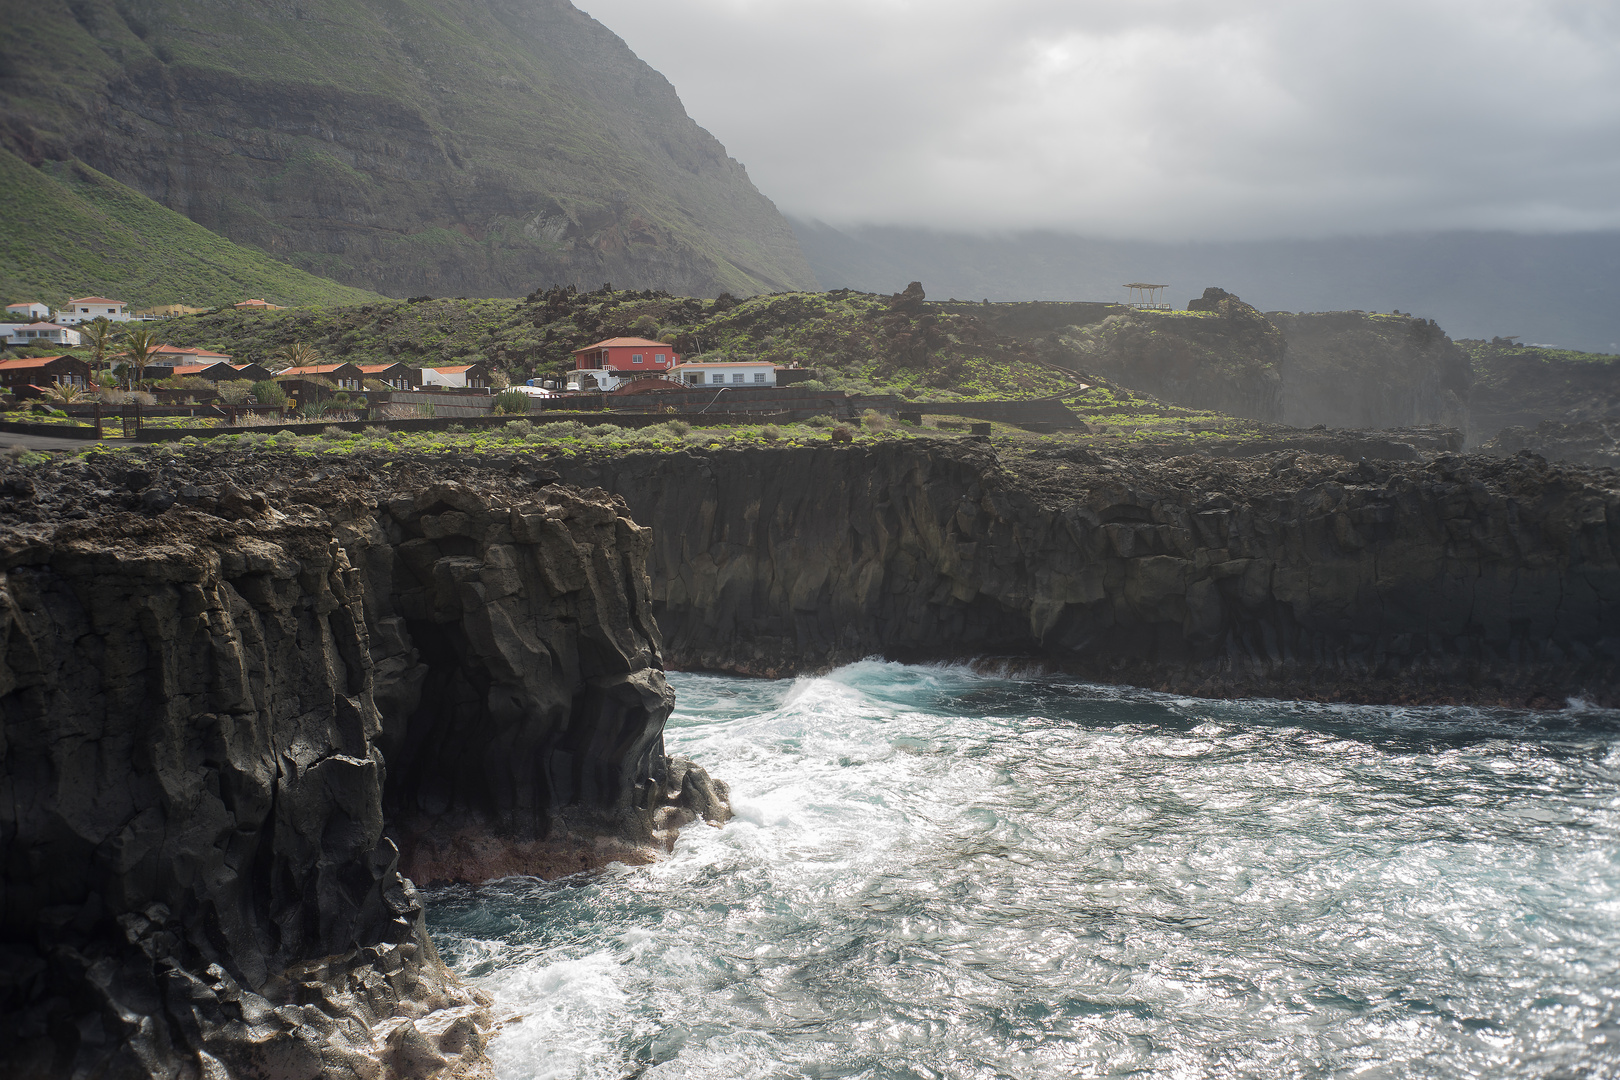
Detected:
left=575, top=0, right=1620, bottom=240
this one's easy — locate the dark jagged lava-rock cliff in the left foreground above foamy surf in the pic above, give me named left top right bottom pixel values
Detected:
left=0, top=455, right=726, bottom=1080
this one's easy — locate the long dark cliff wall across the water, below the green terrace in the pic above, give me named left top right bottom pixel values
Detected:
left=559, top=442, right=1620, bottom=704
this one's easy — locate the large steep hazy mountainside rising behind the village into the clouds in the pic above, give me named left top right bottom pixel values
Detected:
left=0, top=0, right=813, bottom=296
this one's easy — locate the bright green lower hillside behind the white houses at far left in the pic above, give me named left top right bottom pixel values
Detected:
left=0, top=151, right=381, bottom=308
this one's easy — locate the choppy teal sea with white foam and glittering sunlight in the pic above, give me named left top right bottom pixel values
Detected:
left=429, top=662, right=1620, bottom=1080
